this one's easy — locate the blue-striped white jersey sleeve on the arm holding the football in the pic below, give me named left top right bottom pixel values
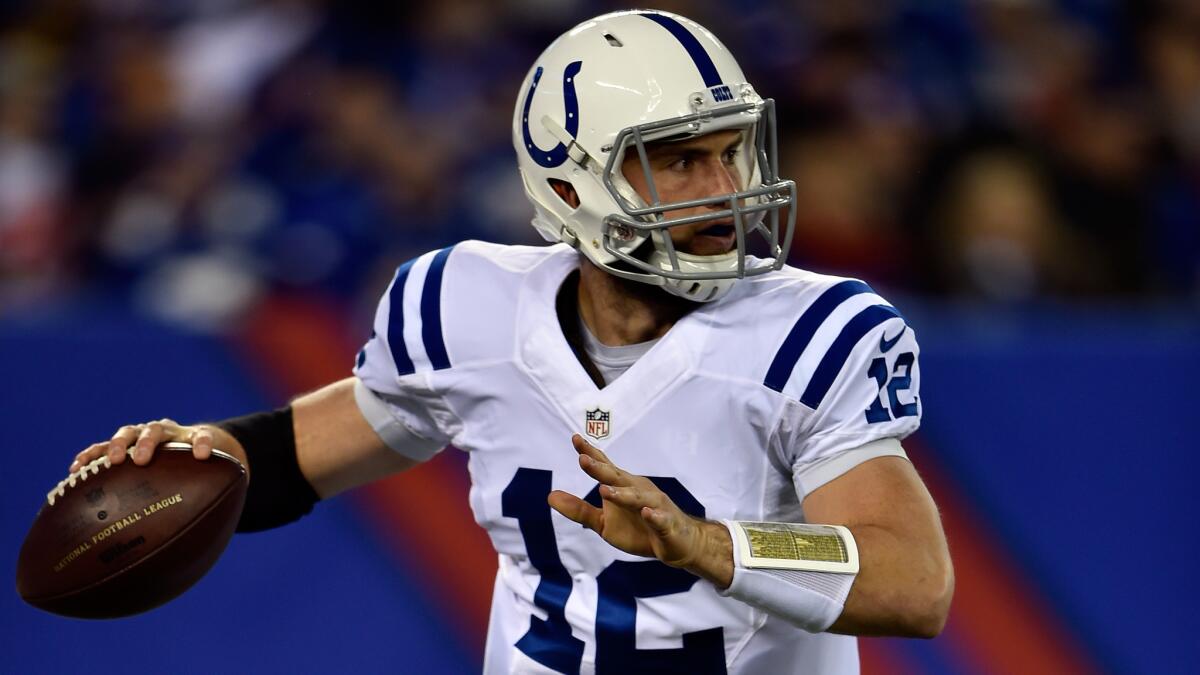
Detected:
left=354, top=249, right=462, bottom=460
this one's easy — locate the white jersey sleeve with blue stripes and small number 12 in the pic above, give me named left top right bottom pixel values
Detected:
left=768, top=281, right=922, bottom=500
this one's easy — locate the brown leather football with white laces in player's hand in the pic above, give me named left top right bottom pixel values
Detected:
left=17, top=443, right=247, bottom=619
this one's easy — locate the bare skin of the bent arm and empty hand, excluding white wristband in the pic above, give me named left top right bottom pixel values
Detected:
left=550, top=436, right=954, bottom=638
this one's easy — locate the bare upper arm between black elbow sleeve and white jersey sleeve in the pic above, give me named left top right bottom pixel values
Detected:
left=292, top=377, right=418, bottom=498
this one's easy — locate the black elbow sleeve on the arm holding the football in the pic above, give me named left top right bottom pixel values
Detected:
left=216, top=406, right=320, bottom=532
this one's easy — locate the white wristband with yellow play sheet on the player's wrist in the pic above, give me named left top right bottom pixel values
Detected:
left=721, top=520, right=858, bottom=633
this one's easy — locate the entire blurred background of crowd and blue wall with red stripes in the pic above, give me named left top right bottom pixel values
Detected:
left=0, top=0, right=1200, bottom=673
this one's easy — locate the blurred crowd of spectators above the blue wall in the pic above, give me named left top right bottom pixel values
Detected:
left=0, top=0, right=1200, bottom=329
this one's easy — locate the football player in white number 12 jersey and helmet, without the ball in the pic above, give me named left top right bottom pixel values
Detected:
left=72, top=11, right=954, bottom=674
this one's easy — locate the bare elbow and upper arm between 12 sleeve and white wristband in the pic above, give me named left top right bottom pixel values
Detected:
left=804, top=456, right=954, bottom=638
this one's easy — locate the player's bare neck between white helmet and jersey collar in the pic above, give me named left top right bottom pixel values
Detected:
left=578, top=256, right=696, bottom=346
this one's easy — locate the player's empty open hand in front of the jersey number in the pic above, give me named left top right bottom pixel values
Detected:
left=546, top=434, right=733, bottom=589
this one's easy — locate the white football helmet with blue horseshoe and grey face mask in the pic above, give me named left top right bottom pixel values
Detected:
left=512, top=11, right=796, bottom=301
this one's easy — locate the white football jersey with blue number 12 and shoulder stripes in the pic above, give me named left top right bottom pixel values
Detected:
left=355, top=241, right=920, bottom=675
